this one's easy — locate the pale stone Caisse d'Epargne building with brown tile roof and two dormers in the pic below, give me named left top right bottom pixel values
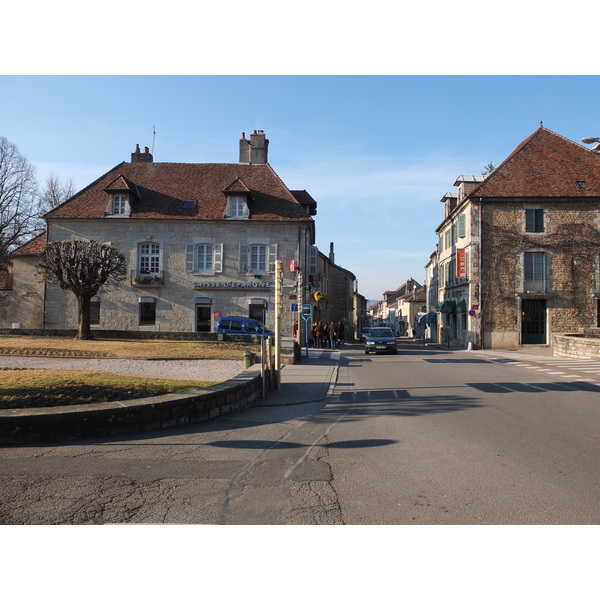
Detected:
left=0, top=131, right=336, bottom=332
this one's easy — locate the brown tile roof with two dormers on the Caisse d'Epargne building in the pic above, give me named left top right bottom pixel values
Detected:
left=47, top=162, right=312, bottom=221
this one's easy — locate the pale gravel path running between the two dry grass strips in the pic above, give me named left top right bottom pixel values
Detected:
left=0, top=356, right=244, bottom=381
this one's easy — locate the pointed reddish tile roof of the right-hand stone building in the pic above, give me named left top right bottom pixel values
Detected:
left=469, top=127, right=600, bottom=198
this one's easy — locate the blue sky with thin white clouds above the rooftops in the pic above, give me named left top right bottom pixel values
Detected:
left=0, top=75, right=600, bottom=299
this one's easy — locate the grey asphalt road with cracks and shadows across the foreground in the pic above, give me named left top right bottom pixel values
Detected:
left=0, top=343, right=600, bottom=525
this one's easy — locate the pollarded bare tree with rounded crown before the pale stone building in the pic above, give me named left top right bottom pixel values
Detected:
left=38, top=240, right=127, bottom=340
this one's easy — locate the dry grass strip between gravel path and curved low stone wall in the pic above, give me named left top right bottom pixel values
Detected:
left=0, top=369, right=216, bottom=409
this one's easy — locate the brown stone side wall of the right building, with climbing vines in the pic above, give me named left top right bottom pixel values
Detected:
left=481, top=200, right=600, bottom=347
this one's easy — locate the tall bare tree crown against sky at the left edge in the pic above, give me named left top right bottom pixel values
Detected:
left=0, top=137, right=39, bottom=250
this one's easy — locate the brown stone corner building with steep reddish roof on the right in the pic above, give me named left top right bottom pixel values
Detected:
left=430, top=126, right=600, bottom=348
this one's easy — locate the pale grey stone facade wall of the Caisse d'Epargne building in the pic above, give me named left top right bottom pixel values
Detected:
left=46, top=219, right=304, bottom=333
